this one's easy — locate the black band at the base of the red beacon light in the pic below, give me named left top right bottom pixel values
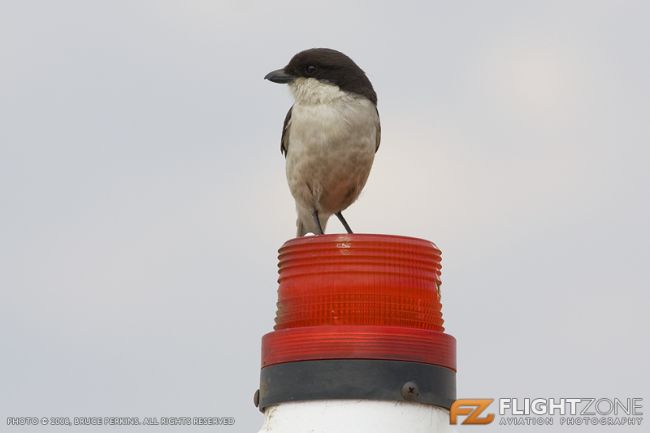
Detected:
left=256, top=359, right=456, bottom=411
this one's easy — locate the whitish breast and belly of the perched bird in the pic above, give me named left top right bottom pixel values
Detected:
left=286, top=78, right=379, bottom=214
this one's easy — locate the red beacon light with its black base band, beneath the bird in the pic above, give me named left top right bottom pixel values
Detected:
left=257, top=234, right=456, bottom=410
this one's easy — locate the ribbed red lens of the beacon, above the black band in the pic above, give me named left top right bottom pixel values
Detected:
left=262, top=234, right=456, bottom=369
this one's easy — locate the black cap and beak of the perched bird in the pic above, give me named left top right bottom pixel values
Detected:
left=264, top=48, right=377, bottom=104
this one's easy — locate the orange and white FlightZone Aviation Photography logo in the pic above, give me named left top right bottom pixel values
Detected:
left=449, top=397, right=643, bottom=426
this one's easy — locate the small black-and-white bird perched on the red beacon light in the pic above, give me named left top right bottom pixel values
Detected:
left=264, top=48, right=381, bottom=237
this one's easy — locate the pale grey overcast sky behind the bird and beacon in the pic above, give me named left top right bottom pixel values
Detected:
left=0, top=0, right=650, bottom=433
